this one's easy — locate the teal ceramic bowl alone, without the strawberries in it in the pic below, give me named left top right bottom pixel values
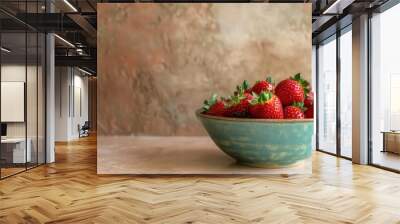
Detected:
left=196, top=109, right=314, bottom=168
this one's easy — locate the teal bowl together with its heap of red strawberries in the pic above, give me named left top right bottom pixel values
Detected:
left=196, top=74, right=314, bottom=168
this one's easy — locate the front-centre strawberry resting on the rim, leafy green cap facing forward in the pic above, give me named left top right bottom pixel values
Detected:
left=249, top=92, right=283, bottom=119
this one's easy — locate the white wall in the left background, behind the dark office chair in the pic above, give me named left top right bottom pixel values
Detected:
left=55, top=67, right=88, bottom=141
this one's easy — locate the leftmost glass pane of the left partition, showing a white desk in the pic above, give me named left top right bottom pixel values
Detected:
left=1, top=32, right=27, bottom=177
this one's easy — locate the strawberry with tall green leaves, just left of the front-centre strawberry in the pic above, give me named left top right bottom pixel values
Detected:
left=226, top=81, right=253, bottom=117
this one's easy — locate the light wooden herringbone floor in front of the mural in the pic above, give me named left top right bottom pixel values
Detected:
left=0, top=138, right=400, bottom=224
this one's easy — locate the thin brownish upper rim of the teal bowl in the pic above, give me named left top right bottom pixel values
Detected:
left=196, top=109, right=314, bottom=123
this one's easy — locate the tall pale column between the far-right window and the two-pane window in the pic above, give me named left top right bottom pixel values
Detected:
left=352, top=15, right=368, bottom=164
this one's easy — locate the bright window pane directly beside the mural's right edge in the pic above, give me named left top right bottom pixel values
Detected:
left=317, top=37, right=336, bottom=156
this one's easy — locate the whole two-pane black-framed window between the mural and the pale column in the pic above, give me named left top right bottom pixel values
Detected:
left=316, top=25, right=352, bottom=159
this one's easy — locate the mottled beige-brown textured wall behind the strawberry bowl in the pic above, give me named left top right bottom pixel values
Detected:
left=98, top=3, right=311, bottom=136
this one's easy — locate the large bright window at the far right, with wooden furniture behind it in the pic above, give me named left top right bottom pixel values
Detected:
left=371, top=5, right=400, bottom=170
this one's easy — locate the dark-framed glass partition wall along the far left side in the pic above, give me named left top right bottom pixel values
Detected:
left=0, top=2, right=46, bottom=179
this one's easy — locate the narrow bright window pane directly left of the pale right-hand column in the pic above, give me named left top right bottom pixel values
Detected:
left=340, top=30, right=353, bottom=158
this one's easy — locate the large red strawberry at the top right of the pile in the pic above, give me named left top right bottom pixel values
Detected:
left=275, top=73, right=310, bottom=106
